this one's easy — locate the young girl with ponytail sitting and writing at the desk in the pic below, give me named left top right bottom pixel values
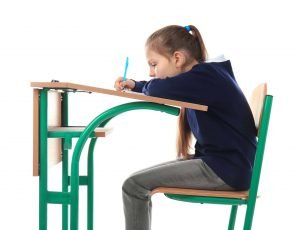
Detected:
left=115, top=25, right=256, bottom=230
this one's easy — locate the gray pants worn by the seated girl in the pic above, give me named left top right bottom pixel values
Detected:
left=122, top=159, right=233, bottom=230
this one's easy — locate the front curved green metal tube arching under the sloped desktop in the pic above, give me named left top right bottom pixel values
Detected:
left=71, top=102, right=180, bottom=230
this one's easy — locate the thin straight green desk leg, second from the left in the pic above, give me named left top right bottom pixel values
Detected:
left=61, top=92, right=69, bottom=230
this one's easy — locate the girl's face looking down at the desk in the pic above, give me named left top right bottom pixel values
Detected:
left=146, top=47, right=182, bottom=79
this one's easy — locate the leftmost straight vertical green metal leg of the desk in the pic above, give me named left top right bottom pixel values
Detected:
left=39, top=89, right=48, bottom=230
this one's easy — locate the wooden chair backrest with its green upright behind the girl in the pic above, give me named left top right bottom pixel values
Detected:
left=248, top=84, right=273, bottom=201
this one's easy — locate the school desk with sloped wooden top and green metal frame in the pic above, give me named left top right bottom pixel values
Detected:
left=31, top=82, right=208, bottom=230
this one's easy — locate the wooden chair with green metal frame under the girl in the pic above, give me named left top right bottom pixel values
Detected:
left=151, top=84, right=273, bottom=230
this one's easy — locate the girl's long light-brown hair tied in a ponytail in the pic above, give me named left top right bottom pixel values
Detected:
left=146, top=25, right=207, bottom=159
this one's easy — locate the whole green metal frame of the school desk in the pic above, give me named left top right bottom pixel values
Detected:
left=34, top=88, right=180, bottom=230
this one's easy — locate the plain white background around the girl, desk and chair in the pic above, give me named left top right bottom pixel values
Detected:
left=0, top=0, right=300, bottom=230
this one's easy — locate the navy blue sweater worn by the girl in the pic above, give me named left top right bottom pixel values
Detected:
left=133, top=61, right=257, bottom=190
